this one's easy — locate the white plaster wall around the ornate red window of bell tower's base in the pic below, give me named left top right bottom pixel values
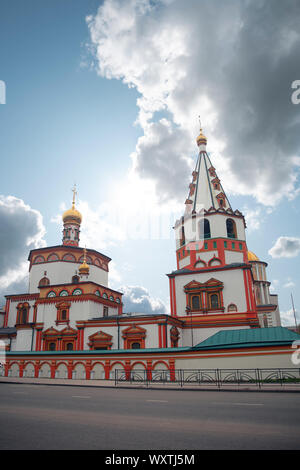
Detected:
left=175, top=269, right=247, bottom=316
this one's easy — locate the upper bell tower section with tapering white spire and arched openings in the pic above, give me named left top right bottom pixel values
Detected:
left=174, top=129, right=247, bottom=269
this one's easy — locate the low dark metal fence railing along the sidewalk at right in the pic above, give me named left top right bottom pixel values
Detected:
left=114, top=368, right=300, bottom=389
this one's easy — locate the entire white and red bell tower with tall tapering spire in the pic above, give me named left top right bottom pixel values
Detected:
left=168, top=124, right=259, bottom=330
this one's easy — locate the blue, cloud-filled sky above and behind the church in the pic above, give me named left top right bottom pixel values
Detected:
left=0, top=0, right=300, bottom=325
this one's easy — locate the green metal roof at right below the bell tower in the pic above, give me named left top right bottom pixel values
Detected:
left=191, top=326, right=300, bottom=350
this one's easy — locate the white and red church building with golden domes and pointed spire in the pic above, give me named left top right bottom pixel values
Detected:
left=0, top=129, right=290, bottom=378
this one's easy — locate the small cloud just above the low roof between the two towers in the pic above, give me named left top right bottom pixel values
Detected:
left=118, top=286, right=168, bottom=314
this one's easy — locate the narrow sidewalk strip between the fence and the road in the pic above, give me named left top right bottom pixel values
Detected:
left=0, top=377, right=300, bottom=392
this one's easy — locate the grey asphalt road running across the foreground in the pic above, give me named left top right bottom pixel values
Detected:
left=0, top=383, right=300, bottom=450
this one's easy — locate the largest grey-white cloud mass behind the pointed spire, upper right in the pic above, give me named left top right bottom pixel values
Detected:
left=86, top=0, right=300, bottom=206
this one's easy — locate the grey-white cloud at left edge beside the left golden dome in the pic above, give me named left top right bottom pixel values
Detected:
left=0, top=195, right=46, bottom=302
